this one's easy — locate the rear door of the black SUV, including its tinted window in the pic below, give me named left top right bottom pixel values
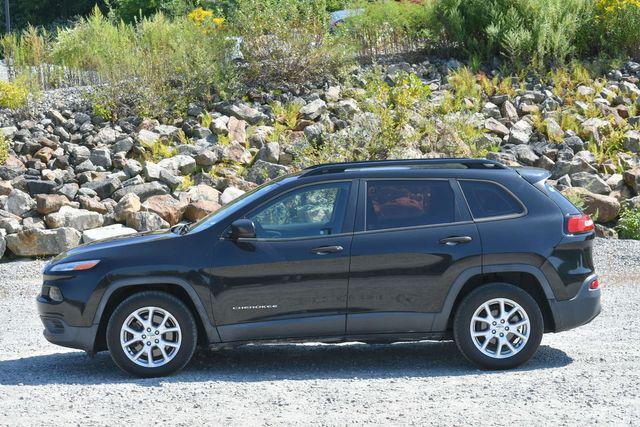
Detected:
left=347, top=179, right=482, bottom=335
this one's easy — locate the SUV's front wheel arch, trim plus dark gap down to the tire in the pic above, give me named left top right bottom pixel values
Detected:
left=94, top=277, right=220, bottom=351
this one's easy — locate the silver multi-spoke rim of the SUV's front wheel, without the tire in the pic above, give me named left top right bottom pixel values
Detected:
left=120, top=307, right=182, bottom=368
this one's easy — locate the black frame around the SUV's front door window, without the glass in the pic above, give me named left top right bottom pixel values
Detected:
left=220, top=179, right=358, bottom=242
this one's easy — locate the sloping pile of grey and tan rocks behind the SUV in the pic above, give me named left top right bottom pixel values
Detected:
left=0, top=57, right=640, bottom=257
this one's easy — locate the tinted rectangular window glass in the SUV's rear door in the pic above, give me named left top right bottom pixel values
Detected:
left=365, top=180, right=455, bottom=230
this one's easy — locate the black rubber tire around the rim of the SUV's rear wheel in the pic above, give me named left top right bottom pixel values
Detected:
left=453, top=283, right=544, bottom=370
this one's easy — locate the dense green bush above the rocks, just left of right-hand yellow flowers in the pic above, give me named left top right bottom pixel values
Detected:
left=436, top=0, right=593, bottom=66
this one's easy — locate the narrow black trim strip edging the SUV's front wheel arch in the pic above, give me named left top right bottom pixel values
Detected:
left=93, top=276, right=220, bottom=344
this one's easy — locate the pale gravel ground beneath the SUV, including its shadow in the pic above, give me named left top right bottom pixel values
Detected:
left=0, top=240, right=640, bottom=425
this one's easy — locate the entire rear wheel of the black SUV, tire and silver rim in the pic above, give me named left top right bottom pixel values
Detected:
left=453, top=283, right=544, bottom=369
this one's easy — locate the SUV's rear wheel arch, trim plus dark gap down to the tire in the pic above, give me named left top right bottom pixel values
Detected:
left=432, top=264, right=556, bottom=332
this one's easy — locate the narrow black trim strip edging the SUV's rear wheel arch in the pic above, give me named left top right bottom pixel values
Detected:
left=431, top=264, right=555, bottom=332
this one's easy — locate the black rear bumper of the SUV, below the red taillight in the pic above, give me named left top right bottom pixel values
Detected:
left=549, top=275, right=602, bottom=332
